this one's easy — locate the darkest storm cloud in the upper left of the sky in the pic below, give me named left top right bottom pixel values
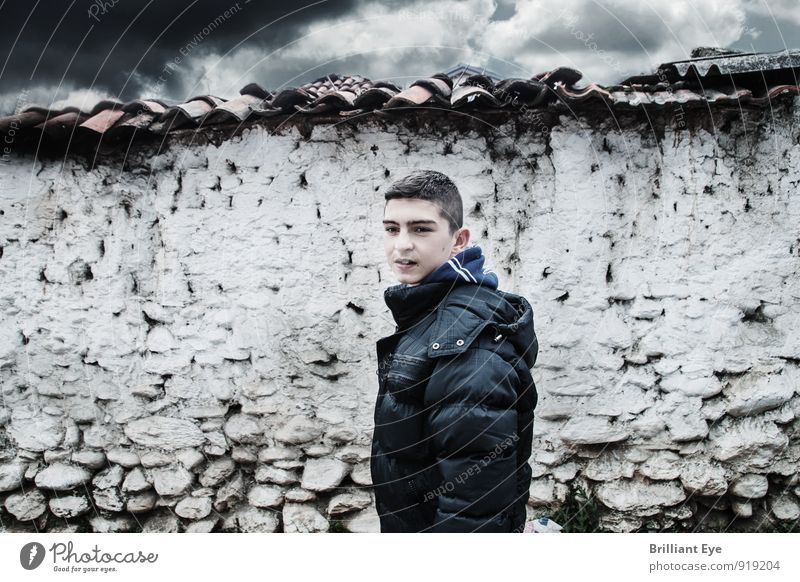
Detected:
left=0, top=0, right=358, bottom=100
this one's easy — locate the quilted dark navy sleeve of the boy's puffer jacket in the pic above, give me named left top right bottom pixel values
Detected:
left=425, top=348, right=527, bottom=532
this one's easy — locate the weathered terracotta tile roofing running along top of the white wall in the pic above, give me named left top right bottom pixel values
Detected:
left=0, top=51, right=800, bottom=157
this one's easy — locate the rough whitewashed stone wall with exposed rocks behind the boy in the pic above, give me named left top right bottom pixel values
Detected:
left=0, top=102, right=800, bottom=531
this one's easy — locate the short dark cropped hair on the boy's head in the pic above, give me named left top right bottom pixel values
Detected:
left=384, top=170, right=464, bottom=235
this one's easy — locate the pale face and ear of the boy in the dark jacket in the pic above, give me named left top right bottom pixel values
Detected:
left=383, top=198, right=469, bottom=285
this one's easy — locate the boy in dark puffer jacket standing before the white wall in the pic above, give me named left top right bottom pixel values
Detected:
left=370, top=170, right=538, bottom=532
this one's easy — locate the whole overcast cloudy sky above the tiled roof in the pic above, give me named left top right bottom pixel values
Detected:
left=0, top=0, right=800, bottom=115
